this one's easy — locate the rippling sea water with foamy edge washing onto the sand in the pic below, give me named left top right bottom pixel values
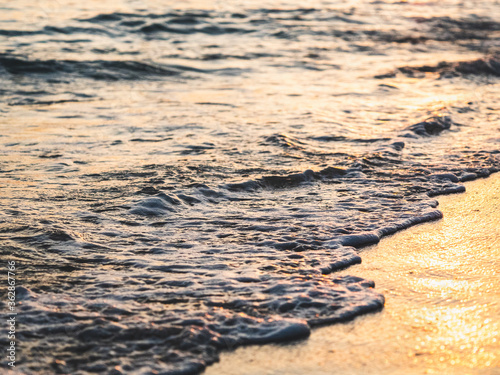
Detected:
left=0, top=0, right=500, bottom=375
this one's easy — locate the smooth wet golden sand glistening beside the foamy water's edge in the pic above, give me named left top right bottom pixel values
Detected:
left=205, top=174, right=500, bottom=375
